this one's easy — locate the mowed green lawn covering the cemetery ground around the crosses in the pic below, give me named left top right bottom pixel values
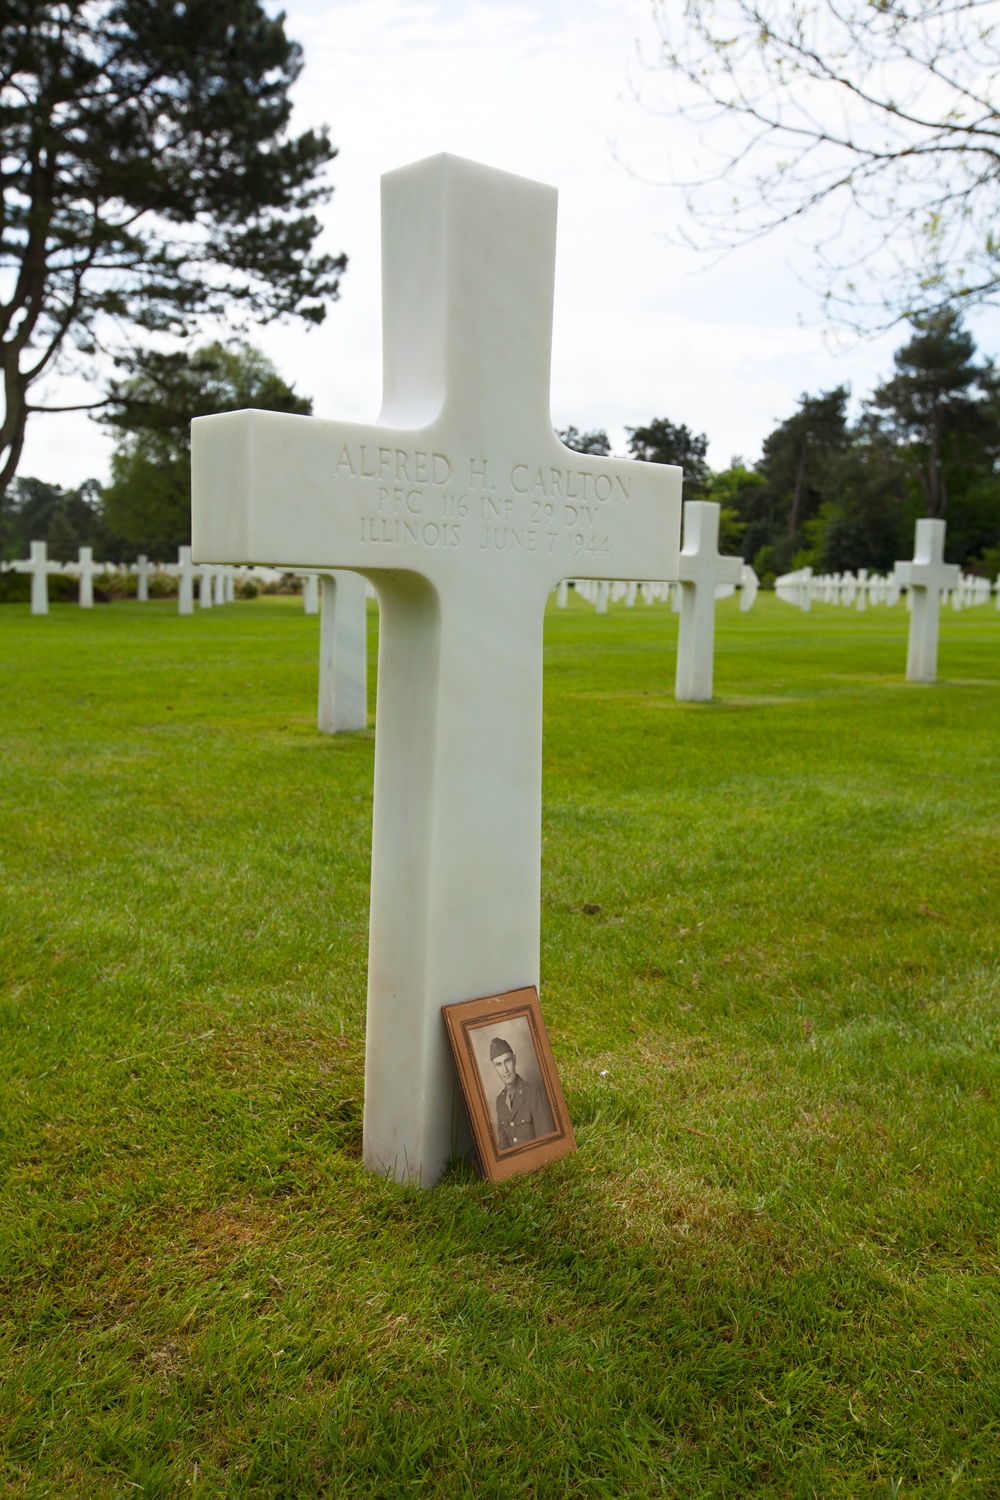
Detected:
left=0, top=596, right=1000, bottom=1500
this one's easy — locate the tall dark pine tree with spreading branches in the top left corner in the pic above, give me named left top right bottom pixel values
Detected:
left=0, top=0, right=346, bottom=500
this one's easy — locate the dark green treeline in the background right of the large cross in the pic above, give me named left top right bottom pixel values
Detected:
left=561, top=311, right=1000, bottom=587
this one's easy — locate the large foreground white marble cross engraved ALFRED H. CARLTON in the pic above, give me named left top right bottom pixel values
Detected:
left=192, top=156, right=681, bottom=1185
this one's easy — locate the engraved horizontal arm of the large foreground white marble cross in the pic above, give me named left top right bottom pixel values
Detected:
left=192, top=411, right=681, bottom=590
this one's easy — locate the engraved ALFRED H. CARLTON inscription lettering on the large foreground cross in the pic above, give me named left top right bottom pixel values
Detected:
left=340, top=443, right=631, bottom=560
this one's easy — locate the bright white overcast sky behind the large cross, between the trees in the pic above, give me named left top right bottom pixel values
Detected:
left=21, top=0, right=997, bottom=485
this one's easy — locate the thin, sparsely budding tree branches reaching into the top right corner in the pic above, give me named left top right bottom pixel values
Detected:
left=655, top=0, right=1000, bottom=326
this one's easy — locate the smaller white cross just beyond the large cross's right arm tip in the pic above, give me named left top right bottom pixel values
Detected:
left=675, top=500, right=744, bottom=702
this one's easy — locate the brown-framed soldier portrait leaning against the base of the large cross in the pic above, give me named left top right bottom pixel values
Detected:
left=441, top=986, right=576, bottom=1182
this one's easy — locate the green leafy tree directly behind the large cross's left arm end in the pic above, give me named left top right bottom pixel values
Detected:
left=99, top=344, right=312, bottom=557
